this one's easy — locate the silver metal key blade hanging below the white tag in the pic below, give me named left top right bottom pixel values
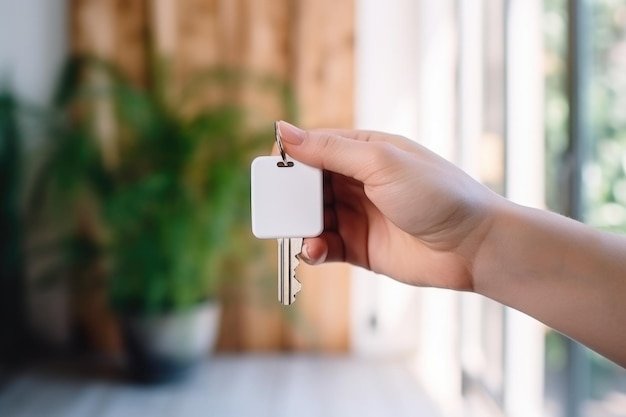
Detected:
left=278, top=238, right=303, bottom=305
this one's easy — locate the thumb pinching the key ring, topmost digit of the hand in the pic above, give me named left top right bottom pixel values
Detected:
left=278, top=121, right=392, bottom=182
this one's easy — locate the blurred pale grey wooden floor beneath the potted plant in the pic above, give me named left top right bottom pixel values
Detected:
left=0, top=355, right=440, bottom=417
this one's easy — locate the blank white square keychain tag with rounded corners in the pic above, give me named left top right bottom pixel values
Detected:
left=251, top=156, right=324, bottom=239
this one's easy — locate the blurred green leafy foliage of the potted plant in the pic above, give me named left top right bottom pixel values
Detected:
left=37, top=57, right=293, bottom=313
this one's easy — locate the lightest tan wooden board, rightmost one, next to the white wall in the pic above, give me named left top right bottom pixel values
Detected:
left=287, top=0, right=355, bottom=352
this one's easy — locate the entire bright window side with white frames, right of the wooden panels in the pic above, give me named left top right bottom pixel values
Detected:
left=353, top=0, right=626, bottom=417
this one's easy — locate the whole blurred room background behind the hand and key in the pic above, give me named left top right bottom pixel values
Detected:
left=0, top=0, right=626, bottom=417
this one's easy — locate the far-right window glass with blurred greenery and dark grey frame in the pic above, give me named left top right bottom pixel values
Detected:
left=544, top=0, right=626, bottom=417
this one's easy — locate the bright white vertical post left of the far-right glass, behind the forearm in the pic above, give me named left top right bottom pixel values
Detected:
left=504, top=0, right=545, bottom=417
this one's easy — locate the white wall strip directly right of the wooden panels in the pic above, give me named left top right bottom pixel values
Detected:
left=351, top=0, right=419, bottom=355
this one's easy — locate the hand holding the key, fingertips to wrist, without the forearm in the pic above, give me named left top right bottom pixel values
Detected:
left=279, top=122, right=503, bottom=290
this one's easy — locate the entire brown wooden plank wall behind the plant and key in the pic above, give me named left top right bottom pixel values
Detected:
left=71, top=0, right=354, bottom=351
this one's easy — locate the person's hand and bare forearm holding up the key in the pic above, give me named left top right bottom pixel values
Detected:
left=279, top=122, right=626, bottom=366
